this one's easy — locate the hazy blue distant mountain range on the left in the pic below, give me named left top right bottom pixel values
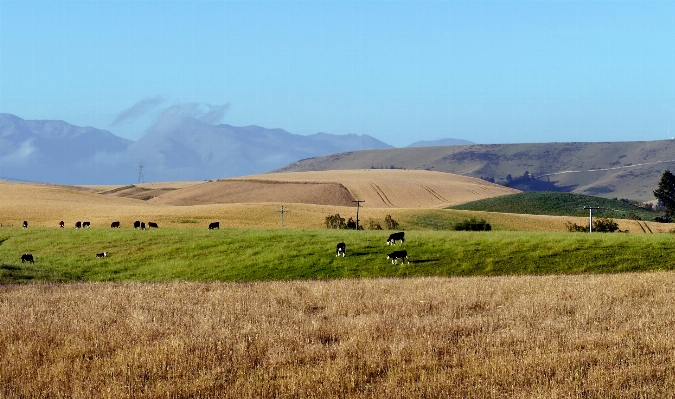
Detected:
left=0, top=113, right=392, bottom=185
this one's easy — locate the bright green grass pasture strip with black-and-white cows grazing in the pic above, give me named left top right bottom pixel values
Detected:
left=0, top=227, right=675, bottom=283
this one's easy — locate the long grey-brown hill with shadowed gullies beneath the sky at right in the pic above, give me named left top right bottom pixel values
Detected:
left=276, top=140, right=675, bottom=201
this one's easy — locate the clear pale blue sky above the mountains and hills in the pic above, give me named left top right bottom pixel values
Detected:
left=0, top=0, right=675, bottom=146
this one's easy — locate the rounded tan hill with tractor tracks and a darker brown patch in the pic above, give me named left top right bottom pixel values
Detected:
left=144, top=169, right=517, bottom=208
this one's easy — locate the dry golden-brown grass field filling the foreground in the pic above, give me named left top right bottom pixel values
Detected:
left=0, top=272, right=675, bottom=398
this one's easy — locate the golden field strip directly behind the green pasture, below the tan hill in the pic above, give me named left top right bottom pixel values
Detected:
left=0, top=180, right=671, bottom=234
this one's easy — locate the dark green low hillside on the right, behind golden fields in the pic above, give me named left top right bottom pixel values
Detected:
left=450, top=191, right=660, bottom=220
